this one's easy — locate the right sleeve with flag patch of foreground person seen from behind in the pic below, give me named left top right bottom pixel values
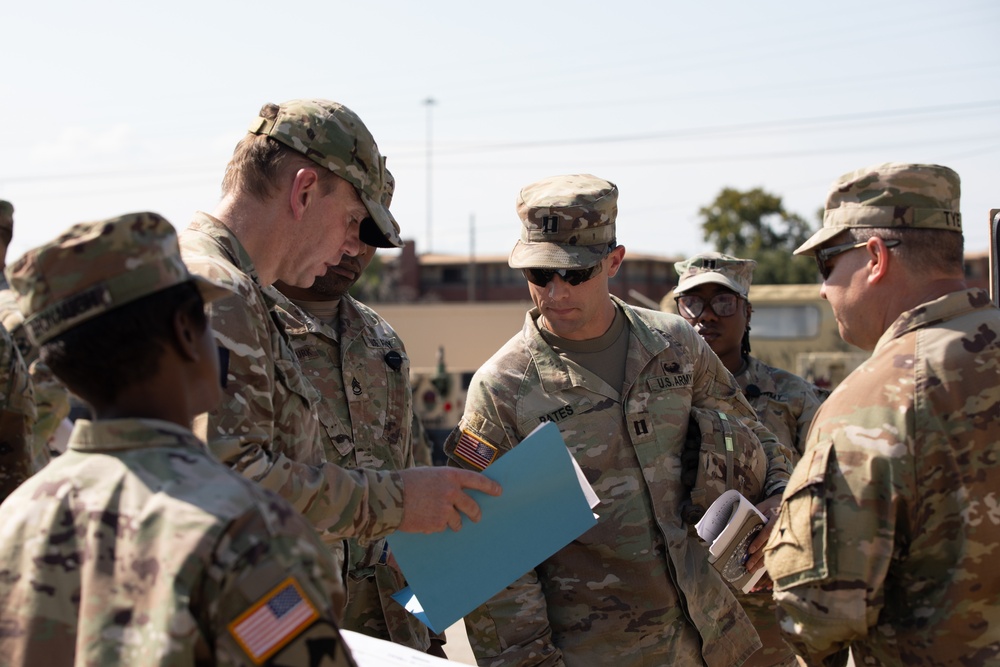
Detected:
left=204, top=503, right=355, bottom=667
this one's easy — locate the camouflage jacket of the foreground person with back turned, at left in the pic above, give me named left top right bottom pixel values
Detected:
left=0, top=419, right=354, bottom=667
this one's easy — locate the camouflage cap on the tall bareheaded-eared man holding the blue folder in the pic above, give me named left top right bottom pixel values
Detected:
left=249, top=99, right=403, bottom=248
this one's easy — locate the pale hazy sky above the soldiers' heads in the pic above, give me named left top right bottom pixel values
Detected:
left=0, top=0, right=1000, bottom=266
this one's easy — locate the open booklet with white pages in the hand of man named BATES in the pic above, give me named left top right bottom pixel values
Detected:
left=695, top=489, right=767, bottom=593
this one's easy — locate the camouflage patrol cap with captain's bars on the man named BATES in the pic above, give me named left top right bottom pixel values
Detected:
left=507, top=174, right=618, bottom=269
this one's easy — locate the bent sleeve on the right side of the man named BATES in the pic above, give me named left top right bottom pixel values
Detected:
left=676, top=320, right=793, bottom=498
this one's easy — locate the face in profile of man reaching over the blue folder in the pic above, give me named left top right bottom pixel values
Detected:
left=278, top=177, right=368, bottom=287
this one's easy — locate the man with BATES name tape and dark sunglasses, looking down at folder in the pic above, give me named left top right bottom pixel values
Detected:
left=445, top=174, right=790, bottom=667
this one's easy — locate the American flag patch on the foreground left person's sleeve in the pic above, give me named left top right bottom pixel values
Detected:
left=229, top=577, right=319, bottom=665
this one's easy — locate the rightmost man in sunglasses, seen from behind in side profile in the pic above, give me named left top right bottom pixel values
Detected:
left=765, top=163, right=1000, bottom=665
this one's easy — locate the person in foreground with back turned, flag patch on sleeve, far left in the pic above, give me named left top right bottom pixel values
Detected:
left=0, top=213, right=354, bottom=667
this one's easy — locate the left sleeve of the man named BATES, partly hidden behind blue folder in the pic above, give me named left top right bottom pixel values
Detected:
left=444, top=373, right=563, bottom=667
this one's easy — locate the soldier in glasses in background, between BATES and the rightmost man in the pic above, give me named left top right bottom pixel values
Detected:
left=674, top=252, right=829, bottom=667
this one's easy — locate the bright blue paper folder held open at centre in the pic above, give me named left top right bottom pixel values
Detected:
left=387, top=422, right=598, bottom=632
